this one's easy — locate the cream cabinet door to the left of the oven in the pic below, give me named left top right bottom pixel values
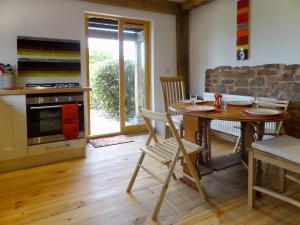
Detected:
left=0, top=95, right=27, bottom=161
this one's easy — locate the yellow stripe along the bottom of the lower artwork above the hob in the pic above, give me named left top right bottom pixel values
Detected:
left=19, top=71, right=81, bottom=77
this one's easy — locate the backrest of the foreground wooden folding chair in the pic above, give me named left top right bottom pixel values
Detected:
left=139, top=106, right=185, bottom=151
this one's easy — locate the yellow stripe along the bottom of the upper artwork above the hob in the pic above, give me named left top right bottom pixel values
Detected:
left=18, top=49, right=80, bottom=58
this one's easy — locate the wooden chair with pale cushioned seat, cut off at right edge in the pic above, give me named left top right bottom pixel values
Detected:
left=248, top=135, right=300, bottom=208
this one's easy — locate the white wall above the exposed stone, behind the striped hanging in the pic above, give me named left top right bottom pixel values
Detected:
left=190, top=0, right=300, bottom=96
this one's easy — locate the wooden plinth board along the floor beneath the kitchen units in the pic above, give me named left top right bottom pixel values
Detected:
left=0, top=148, right=85, bottom=173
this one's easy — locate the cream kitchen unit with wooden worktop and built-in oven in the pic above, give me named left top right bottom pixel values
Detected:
left=0, top=86, right=91, bottom=173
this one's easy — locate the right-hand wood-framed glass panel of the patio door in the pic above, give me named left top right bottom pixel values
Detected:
left=119, top=20, right=150, bottom=131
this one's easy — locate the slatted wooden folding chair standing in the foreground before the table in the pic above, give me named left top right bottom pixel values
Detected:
left=127, top=108, right=207, bottom=220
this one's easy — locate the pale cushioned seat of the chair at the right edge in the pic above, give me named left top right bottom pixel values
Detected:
left=252, top=135, right=300, bottom=164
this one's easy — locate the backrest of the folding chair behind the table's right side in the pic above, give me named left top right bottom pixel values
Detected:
left=259, top=98, right=290, bottom=135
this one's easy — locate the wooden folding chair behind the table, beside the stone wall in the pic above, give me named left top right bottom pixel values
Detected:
left=233, top=98, right=289, bottom=153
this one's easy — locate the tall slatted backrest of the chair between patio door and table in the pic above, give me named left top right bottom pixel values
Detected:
left=160, top=76, right=186, bottom=112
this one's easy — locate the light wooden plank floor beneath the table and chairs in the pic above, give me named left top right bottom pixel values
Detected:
left=0, top=136, right=300, bottom=225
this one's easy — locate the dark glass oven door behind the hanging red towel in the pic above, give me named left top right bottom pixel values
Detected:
left=27, top=102, right=84, bottom=145
